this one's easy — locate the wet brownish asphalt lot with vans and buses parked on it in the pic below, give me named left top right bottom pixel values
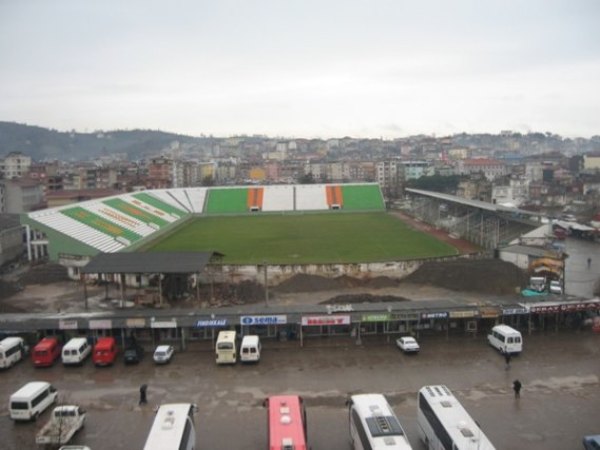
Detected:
left=0, top=331, right=600, bottom=450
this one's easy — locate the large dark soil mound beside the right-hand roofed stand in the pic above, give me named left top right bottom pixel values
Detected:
left=402, top=259, right=528, bottom=295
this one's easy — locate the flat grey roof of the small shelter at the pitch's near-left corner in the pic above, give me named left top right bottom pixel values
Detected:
left=81, top=252, right=223, bottom=273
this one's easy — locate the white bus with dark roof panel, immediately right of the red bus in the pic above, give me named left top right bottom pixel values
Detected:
left=348, top=394, right=412, bottom=450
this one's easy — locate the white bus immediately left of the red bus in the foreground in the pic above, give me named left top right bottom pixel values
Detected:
left=144, top=403, right=198, bottom=450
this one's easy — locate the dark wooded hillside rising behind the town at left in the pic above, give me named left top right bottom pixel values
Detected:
left=0, top=122, right=200, bottom=161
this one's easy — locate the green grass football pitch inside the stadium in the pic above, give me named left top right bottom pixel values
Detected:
left=145, top=212, right=457, bottom=264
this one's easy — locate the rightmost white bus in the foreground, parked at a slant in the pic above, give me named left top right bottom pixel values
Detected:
left=417, top=385, right=495, bottom=450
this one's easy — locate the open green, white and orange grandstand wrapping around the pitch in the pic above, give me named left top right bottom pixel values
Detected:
left=21, top=183, right=385, bottom=261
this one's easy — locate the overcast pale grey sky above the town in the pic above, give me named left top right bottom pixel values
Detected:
left=0, top=0, right=600, bottom=138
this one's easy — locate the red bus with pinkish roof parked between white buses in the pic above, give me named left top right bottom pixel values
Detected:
left=263, top=395, right=308, bottom=450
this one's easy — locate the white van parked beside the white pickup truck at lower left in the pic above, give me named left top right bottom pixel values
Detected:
left=8, top=381, right=58, bottom=420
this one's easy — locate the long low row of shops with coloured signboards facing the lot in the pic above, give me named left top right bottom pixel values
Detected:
left=0, top=298, right=600, bottom=349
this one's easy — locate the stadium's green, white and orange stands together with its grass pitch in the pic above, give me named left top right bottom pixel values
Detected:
left=21, top=183, right=457, bottom=277
